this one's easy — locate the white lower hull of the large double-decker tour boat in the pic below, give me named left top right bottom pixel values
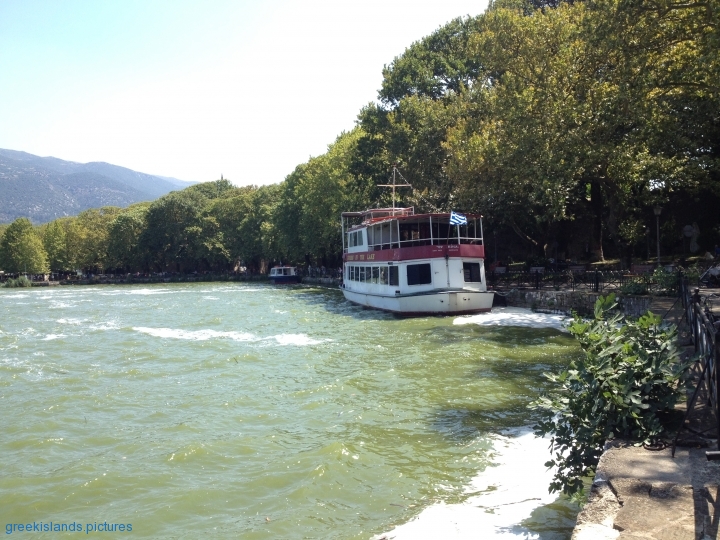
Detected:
left=343, top=289, right=495, bottom=315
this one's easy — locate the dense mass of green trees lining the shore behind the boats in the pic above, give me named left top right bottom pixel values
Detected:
left=2, top=0, right=720, bottom=272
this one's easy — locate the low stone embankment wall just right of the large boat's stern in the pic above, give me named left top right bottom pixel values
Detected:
left=495, top=289, right=652, bottom=317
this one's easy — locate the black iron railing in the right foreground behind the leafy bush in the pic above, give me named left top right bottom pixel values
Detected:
left=672, top=278, right=720, bottom=459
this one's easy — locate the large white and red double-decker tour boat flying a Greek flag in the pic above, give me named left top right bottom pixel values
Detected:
left=341, top=208, right=494, bottom=315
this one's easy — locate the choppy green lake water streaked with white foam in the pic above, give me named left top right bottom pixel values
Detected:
left=0, top=284, right=578, bottom=539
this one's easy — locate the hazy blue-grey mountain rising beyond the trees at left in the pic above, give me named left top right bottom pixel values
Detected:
left=0, top=149, right=197, bottom=223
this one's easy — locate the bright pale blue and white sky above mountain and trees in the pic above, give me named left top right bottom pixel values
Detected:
left=0, top=0, right=487, bottom=185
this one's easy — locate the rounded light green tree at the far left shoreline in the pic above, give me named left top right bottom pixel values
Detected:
left=0, top=218, right=49, bottom=274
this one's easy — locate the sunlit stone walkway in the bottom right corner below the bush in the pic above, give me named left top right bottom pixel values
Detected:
left=572, top=298, right=720, bottom=540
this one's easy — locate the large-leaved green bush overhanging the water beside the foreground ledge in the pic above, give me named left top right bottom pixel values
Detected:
left=531, top=294, right=689, bottom=494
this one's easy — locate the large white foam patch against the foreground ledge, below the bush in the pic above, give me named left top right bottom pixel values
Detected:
left=380, top=428, right=557, bottom=540
